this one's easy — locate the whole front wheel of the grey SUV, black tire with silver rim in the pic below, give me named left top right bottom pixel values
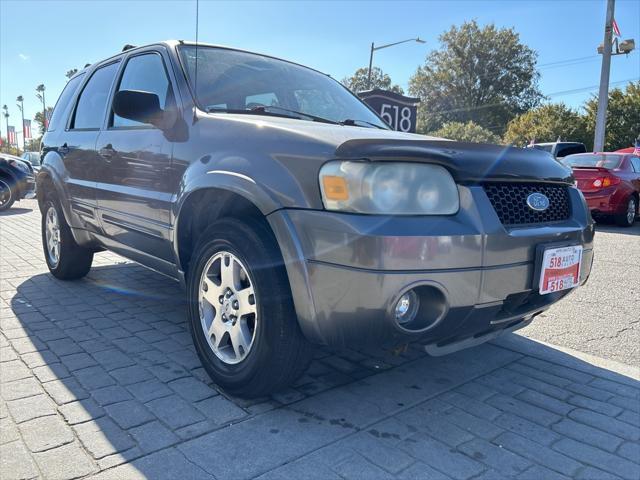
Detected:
left=187, top=219, right=312, bottom=398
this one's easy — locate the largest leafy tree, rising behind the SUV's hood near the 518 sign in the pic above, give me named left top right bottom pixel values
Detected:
left=409, top=20, right=543, bottom=134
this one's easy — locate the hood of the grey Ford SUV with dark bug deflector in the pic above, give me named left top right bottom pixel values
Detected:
left=210, top=114, right=573, bottom=183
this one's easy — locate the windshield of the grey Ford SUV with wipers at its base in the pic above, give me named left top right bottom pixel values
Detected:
left=179, top=45, right=389, bottom=129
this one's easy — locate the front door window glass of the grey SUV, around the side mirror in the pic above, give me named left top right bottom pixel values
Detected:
left=111, top=53, right=173, bottom=128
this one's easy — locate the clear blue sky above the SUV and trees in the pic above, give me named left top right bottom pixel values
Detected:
left=0, top=0, right=640, bottom=142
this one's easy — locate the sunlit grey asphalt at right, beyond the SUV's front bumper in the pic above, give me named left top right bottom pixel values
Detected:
left=519, top=221, right=640, bottom=366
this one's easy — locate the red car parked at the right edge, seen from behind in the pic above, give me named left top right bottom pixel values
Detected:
left=561, top=152, right=640, bottom=227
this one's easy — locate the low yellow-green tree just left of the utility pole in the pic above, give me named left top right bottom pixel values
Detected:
left=504, top=103, right=593, bottom=147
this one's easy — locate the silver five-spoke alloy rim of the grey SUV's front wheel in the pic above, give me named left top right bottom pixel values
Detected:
left=199, top=251, right=258, bottom=365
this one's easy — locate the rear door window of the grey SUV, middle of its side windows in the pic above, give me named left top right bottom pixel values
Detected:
left=71, top=62, right=119, bottom=130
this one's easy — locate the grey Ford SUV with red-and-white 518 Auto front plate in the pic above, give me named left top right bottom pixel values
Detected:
left=38, top=41, right=594, bottom=396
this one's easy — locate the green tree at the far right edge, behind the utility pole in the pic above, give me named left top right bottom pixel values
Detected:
left=584, top=81, right=640, bottom=152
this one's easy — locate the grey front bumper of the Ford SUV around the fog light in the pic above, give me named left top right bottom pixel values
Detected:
left=269, top=186, right=594, bottom=347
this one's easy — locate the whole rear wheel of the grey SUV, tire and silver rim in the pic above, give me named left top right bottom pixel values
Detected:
left=42, top=199, right=93, bottom=280
